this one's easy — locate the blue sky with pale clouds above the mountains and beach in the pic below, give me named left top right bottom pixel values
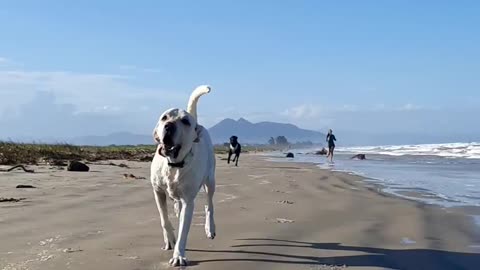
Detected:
left=0, top=0, right=480, bottom=144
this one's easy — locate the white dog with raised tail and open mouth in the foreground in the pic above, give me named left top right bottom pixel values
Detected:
left=151, top=85, right=215, bottom=266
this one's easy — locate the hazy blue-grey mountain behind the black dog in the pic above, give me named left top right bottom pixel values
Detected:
left=209, top=118, right=325, bottom=143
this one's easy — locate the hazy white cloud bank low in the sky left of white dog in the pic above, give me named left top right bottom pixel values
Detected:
left=0, top=57, right=201, bottom=138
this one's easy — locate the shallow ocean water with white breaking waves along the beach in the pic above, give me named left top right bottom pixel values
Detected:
left=266, top=143, right=480, bottom=207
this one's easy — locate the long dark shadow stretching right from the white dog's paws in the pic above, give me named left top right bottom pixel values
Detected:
left=189, top=238, right=480, bottom=270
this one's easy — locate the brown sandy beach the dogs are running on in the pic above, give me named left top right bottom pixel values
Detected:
left=0, top=155, right=480, bottom=270
